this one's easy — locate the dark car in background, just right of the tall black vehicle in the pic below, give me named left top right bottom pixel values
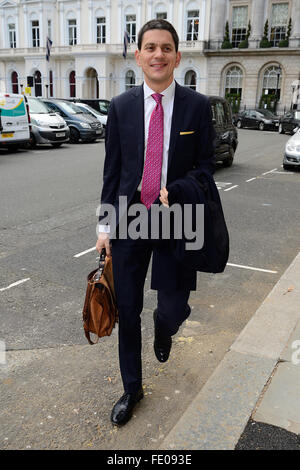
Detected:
left=235, top=109, right=279, bottom=131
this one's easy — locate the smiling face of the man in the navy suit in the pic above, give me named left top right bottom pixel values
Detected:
left=135, top=29, right=181, bottom=91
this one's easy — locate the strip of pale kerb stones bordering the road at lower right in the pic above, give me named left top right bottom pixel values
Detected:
left=160, top=252, right=300, bottom=450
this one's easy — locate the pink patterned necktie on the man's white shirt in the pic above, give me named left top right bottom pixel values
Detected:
left=141, top=93, right=164, bottom=209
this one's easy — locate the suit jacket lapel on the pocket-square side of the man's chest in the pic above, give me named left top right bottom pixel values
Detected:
left=168, top=82, right=187, bottom=169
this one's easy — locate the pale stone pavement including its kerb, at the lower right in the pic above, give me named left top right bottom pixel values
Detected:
left=160, top=253, right=300, bottom=450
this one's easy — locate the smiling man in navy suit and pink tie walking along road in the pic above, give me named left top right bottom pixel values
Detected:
left=96, top=20, right=215, bottom=426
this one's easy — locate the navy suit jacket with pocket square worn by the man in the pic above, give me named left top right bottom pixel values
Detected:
left=99, top=83, right=215, bottom=228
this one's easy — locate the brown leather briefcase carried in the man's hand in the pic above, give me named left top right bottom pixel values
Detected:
left=82, top=250, right=118, bottom=344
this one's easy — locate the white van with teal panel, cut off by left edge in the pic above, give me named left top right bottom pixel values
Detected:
left=0, top=93, right=30, bottom=148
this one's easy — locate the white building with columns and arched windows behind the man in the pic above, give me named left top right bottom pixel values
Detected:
left=0, top=0, right=300, bottom=111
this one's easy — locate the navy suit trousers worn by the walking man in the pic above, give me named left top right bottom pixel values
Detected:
left=112, top=239, right=190, bottom=393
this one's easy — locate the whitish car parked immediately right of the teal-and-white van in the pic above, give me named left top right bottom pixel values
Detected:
left=28, top=97, right=70, bottom=147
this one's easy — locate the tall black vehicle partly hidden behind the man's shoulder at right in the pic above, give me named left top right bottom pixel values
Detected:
left=209, top=96, right=238, bottom=167
